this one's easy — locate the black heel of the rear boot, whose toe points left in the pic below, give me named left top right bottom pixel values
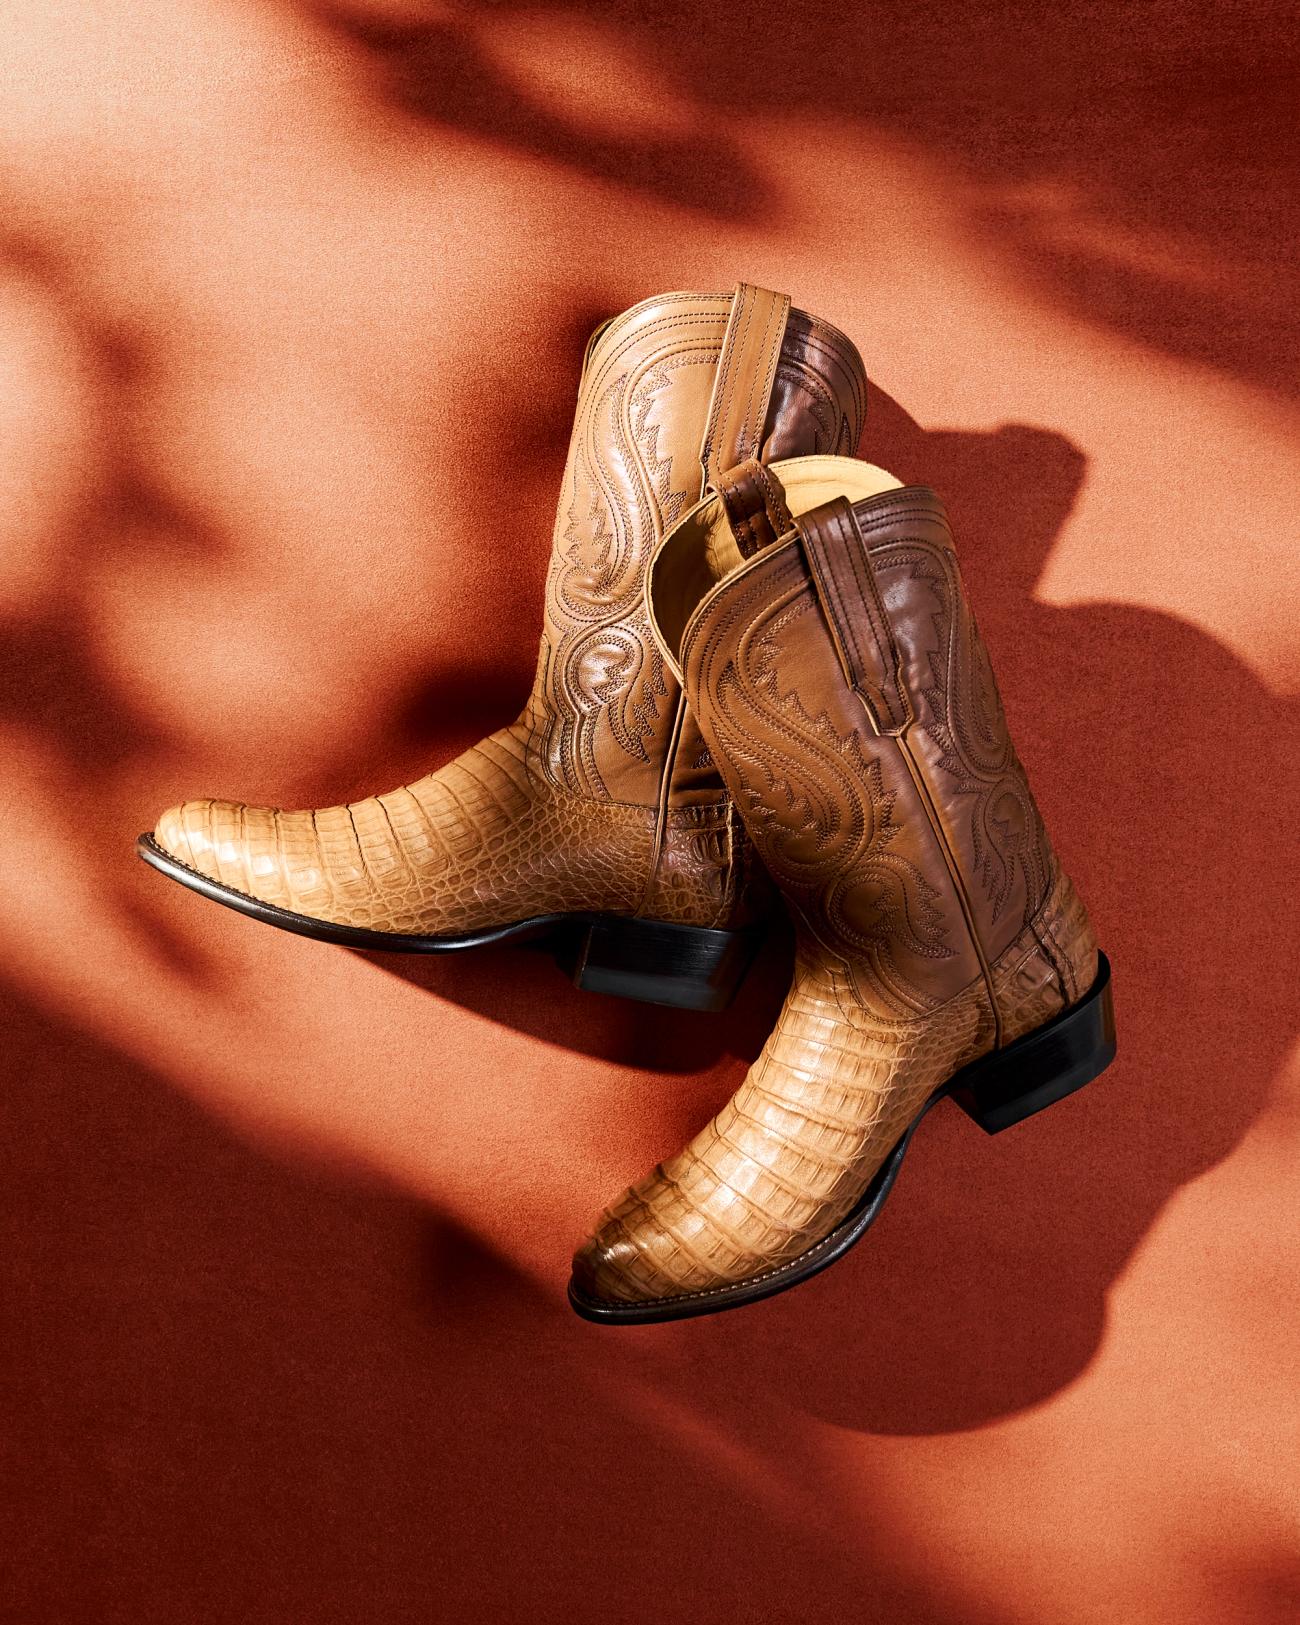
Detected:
left=561, top=918, right=762, bottom=1011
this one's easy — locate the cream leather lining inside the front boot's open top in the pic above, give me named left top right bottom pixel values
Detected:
left=650, top=457, right=902, bottom=678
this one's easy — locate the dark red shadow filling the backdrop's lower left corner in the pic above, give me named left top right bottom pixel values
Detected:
left=10, top=1014, right=1009, bottom=1625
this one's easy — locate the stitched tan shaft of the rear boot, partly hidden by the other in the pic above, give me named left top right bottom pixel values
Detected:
left=527, top=294, right=866, bottom=806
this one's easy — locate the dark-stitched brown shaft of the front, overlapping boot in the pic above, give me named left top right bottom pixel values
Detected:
left=653, top=458, right=1090, bottom=1025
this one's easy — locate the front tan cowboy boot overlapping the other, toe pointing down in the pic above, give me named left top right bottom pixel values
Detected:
left=570, top=457, right=1115, bottom=1321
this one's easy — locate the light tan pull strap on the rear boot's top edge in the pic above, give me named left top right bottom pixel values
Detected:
left=700, top=283, right=790, bottom=491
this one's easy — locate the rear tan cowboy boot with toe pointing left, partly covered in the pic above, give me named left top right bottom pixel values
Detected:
left=138, top=284, right=866, bottom=1009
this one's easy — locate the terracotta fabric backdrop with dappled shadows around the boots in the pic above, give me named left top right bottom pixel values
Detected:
left=0, top=0, right=1300, bottom=1625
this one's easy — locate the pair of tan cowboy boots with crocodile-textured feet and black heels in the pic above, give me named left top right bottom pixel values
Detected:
left=140, top=284, right=1115, bottom=1323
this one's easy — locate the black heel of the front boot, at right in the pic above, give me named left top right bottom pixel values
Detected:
left=949, top=954, right=1115, bottom=1134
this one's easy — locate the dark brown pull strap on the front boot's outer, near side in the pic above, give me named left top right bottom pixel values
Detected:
left=795, top=497, right=912, bottom=735
